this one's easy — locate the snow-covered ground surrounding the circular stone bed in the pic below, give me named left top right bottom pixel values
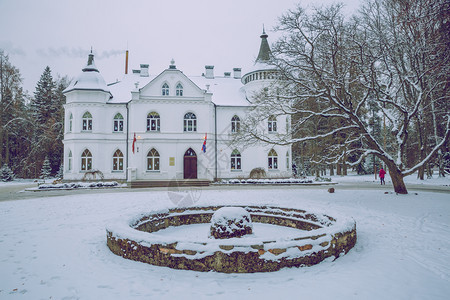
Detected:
left=0, top=184, right=450, bottom=299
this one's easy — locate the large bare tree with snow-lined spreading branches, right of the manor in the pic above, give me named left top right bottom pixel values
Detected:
left=240, top=0, right=450, bottom=194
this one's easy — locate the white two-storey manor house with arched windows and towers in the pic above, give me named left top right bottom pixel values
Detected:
left=63, top=31, right=292, bottom=181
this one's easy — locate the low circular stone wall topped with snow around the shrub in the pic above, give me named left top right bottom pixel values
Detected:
left=106, top=206, right=356, bottom=273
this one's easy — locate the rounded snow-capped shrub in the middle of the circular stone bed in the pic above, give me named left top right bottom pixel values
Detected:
left=210, top=207, right=253, bottom=239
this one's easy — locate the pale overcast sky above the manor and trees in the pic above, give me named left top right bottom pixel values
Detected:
left=0, top=0, right=360, bottom=93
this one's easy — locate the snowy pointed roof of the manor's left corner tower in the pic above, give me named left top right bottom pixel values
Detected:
left=63, top=51, right=111, bottom=103
